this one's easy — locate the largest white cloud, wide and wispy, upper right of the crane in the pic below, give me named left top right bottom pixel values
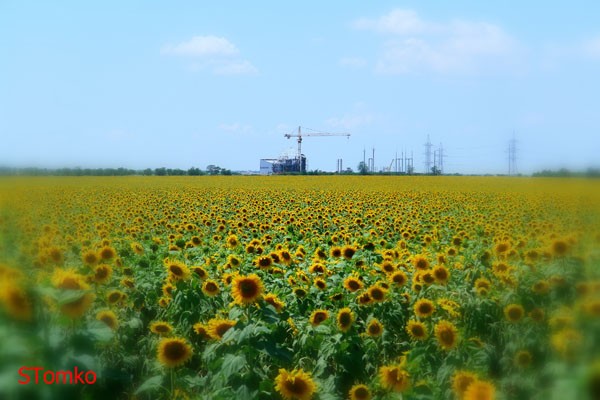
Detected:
left=354, top=9, right=518, bottom=74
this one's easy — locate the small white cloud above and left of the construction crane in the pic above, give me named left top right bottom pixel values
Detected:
left=161, top=35, right=258, bottom=75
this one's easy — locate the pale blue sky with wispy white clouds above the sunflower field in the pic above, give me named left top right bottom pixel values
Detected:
left=0, top=0, right=600, bottom=173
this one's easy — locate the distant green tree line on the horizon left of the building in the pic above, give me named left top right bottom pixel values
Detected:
left=0, top=164, right=234, bottom=176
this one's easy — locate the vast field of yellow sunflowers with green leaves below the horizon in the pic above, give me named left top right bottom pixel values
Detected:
left=0, top=176, right=600, bottom=400
